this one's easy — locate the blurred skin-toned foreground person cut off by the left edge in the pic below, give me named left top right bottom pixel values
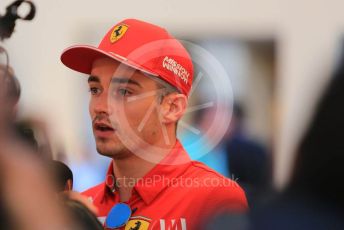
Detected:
left=0, top=48, right=72, bottom=229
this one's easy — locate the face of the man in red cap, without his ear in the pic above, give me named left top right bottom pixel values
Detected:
left=88, top=58, right=162, bottom=159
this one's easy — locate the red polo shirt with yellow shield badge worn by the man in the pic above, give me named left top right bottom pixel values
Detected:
left=83, top=141, right=247, bottom=230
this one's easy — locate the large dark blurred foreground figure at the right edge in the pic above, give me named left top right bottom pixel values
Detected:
left=207, top=48, right=344, bottom=230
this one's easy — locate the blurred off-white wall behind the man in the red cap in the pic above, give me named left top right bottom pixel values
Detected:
left=0, top=0, right=344, bottom=187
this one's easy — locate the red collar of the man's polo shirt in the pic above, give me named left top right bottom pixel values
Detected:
left=104, top=140, right=191, bottom=205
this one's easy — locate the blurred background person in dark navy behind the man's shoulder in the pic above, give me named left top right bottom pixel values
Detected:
left=225, top=102, right=271, bottom=206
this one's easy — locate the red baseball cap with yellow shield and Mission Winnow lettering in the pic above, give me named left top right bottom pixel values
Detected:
left=61, top=19, right=193, bottom=95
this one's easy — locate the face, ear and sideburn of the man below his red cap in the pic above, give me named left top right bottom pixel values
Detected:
left=88, top=58, right=187, bottom=158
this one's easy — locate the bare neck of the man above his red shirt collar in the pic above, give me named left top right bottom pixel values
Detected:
left=113, top=139, right=176, bottom=202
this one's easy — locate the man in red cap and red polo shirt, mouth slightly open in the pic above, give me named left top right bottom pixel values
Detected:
left=61, top=19, right=247, bottom=229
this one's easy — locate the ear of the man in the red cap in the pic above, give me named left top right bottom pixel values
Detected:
left=161, top=93, right=188, bottom=124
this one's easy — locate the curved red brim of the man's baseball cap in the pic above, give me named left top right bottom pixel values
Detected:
left=61, top=45, right=158, bottom=76
